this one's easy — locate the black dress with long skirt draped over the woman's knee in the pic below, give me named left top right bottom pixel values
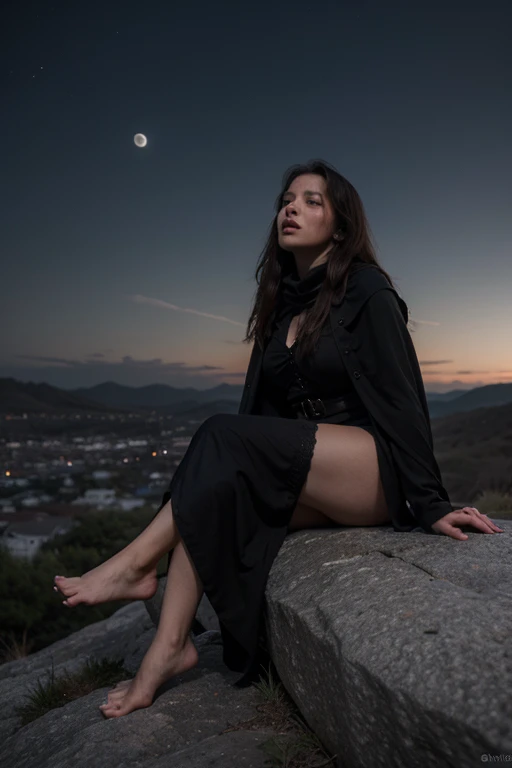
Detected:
left=156, top=280, right=394, bottom=686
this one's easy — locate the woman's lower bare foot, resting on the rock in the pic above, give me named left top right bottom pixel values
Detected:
left=100, top=637, right=199, bottom=718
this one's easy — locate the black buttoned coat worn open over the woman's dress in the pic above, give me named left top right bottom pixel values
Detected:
left=238, top=263, right=454, bottom=533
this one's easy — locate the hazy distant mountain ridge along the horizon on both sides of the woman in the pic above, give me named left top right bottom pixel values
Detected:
left=0, top=378, right=512, bottom=419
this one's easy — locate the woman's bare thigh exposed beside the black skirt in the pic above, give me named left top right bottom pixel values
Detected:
left=289, top=424, right=390, bottom=529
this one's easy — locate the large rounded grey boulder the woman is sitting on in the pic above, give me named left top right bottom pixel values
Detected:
left=265, top=521, right=512, bottom=768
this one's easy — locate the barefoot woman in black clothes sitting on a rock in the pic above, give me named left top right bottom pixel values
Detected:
left=54, top=161, right=500, bottom=717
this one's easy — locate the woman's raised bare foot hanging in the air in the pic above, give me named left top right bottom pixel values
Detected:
left=54, top=552, right=158, bottom=607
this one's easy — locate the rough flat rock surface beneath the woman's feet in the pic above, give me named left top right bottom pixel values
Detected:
left=0, top=602, right=290, bottom=768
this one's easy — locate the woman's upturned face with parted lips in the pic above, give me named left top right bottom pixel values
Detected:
left=277, top=173, right=336, bottom=255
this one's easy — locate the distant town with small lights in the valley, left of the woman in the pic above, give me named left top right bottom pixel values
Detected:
left=0, top=378, right=242, bottom=559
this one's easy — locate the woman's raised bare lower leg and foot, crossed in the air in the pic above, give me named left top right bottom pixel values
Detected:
left=54, top=500, right=180, bottom=607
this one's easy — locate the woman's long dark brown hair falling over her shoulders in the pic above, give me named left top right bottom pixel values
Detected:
left=243, top=160, right=406, bottom=364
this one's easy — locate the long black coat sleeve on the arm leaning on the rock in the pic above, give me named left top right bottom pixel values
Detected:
left=354, top=287, right=454, bottom=533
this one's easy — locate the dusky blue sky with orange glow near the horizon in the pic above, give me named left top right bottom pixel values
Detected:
left=0, top=0, right=512, bottom=392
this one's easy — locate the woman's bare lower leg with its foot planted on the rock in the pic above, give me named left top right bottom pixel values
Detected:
left=100, top=540, right=203, bottom=717
